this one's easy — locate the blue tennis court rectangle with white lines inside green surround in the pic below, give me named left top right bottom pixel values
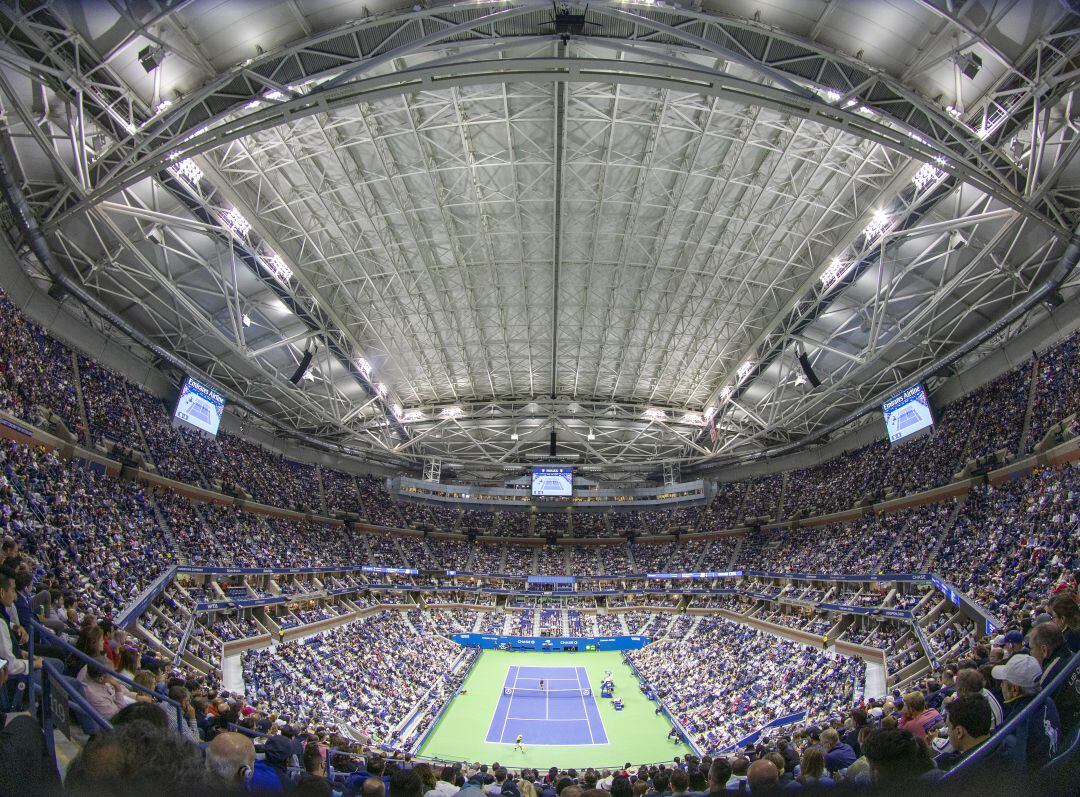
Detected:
left=486, top=666, right=607, bottom=747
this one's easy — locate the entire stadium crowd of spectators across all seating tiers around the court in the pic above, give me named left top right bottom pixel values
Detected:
left=0, top=293, right=1080, bottom=794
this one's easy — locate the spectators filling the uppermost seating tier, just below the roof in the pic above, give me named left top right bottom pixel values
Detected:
left=6, top=295, right=1080, bottom=546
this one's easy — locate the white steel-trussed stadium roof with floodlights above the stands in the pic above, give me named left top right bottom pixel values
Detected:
left=0, top=0, right=1080, bottom=476
